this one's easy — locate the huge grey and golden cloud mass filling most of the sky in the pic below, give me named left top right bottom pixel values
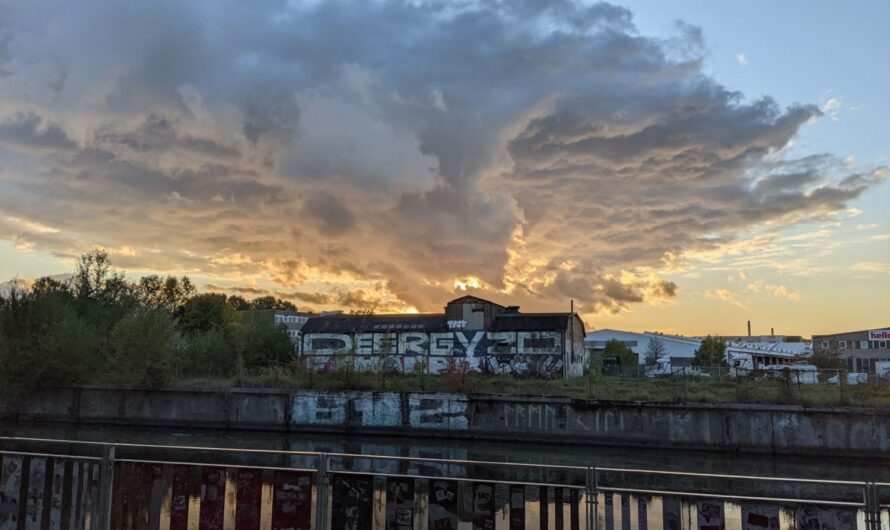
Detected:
left=0, top=0, right=885, bottom=312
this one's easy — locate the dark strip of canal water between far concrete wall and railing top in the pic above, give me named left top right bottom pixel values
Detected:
left=0, top=423, right=890, bottom=482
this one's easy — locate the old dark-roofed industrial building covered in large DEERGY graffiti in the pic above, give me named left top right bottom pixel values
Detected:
left=300, top=296, right=587, bottom=378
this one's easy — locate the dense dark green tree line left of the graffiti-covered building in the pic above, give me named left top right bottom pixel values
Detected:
left=0, top=250, right=297, bottom=391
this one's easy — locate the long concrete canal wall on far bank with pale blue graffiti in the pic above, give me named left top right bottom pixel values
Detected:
left=5, top=388, right=890, bottom=458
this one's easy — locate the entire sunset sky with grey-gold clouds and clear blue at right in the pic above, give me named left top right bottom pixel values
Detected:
left=0, top=0, right=890, bottom=335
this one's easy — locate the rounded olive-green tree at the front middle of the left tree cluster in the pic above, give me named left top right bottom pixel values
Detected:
left=109, top=309, right=176, bottom=387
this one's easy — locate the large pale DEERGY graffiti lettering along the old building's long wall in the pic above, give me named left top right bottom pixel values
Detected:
left=302, top=331, right=583, bottom=378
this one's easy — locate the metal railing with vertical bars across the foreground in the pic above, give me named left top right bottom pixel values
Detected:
left=0, top=437, right=890, bottom=530
